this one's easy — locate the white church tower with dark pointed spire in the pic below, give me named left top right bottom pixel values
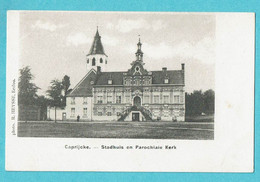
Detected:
left=87, top=29, right=108, bottom=72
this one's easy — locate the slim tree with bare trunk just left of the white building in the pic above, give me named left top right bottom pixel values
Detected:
left=47, top=80, right=64, bottom=122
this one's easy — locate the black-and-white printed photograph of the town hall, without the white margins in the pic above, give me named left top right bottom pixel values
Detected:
left=17, top=11, right=216, bottom=140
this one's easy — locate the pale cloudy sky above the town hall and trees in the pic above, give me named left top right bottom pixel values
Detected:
left=19, top=11, right=216, bottom=95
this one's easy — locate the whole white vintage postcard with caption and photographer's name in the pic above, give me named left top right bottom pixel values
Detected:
left=6, top=11, right=255, bottom=172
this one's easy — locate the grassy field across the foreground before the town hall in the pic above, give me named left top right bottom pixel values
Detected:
left=18, top=121, right=214, bottom=140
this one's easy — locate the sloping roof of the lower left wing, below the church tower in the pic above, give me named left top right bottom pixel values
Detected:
left=67, top=70, right=96, bottom=97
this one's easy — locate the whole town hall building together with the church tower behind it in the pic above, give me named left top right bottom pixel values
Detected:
left=66, top=31, right=185, bottom=121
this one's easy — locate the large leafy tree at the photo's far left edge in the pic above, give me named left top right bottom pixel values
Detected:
left=18, top=66, right=39, bottom=105
